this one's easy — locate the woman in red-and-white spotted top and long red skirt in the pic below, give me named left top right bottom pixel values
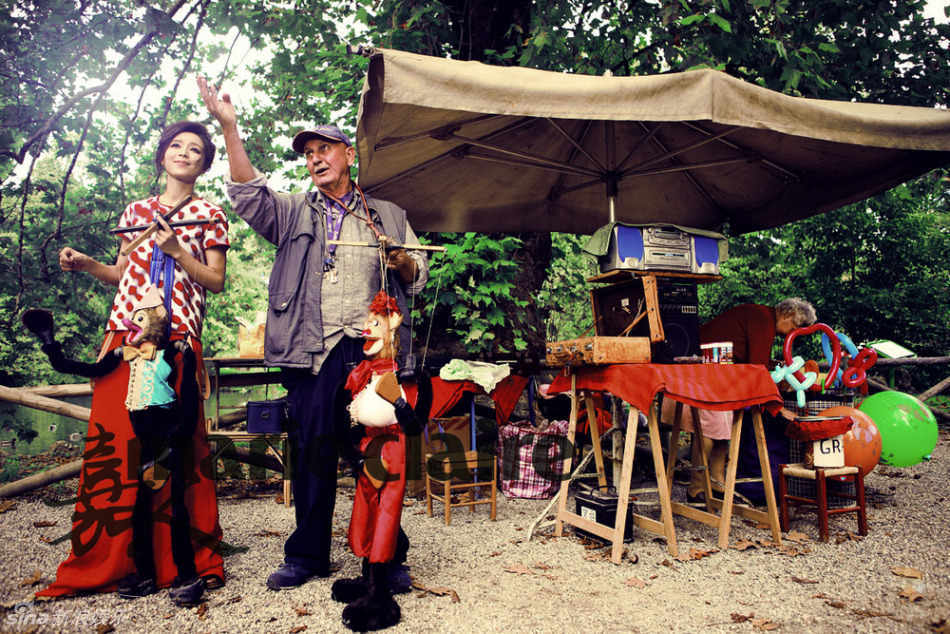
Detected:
left=37, top=121, right=229, bottom=596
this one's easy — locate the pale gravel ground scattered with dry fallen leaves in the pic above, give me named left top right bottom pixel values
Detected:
left=0, top=431, right=950, bottom=634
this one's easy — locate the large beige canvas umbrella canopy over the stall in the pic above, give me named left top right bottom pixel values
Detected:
left=357, top=49, right=950, bottom=234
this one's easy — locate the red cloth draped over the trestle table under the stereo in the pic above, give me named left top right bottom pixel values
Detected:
left=548, top=363, right=784, bottom=414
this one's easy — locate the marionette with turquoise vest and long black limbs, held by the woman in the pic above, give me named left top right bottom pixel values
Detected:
left=23, top=287, right=204, bottom=605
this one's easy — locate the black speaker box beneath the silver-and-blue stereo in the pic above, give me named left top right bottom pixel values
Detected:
left=591, top=277, right=700, bottom=363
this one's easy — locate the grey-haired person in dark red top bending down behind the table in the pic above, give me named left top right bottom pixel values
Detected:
left=661, top=297, right=816, bottom=504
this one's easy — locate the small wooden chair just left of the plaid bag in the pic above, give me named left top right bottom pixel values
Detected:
left=426, top=451, right=498, bottom=525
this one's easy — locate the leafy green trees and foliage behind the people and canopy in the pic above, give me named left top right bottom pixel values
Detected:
left=0, top=0, right=950, bottom=385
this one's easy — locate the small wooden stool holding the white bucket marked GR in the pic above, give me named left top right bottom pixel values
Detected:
left=779, top=463, right=868, bottom=542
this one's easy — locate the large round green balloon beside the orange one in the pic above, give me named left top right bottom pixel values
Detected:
left=858, top=392, right=937, bottom=467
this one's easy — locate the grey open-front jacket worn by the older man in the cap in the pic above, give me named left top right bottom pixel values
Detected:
left=227, top=172, right=424, bottom=368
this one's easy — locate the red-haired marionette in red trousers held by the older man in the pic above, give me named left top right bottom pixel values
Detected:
left=332, top=291, right=432, bottom=632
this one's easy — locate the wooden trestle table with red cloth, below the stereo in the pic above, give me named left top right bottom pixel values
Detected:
left=549, top=363, right=783, bottom=564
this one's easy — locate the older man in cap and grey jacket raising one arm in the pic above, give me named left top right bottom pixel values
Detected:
left=198, top=78, right=428, bottom=590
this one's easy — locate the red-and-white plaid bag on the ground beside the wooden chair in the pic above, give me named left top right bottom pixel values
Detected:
left=496, top=420, right=573, bottom=500
